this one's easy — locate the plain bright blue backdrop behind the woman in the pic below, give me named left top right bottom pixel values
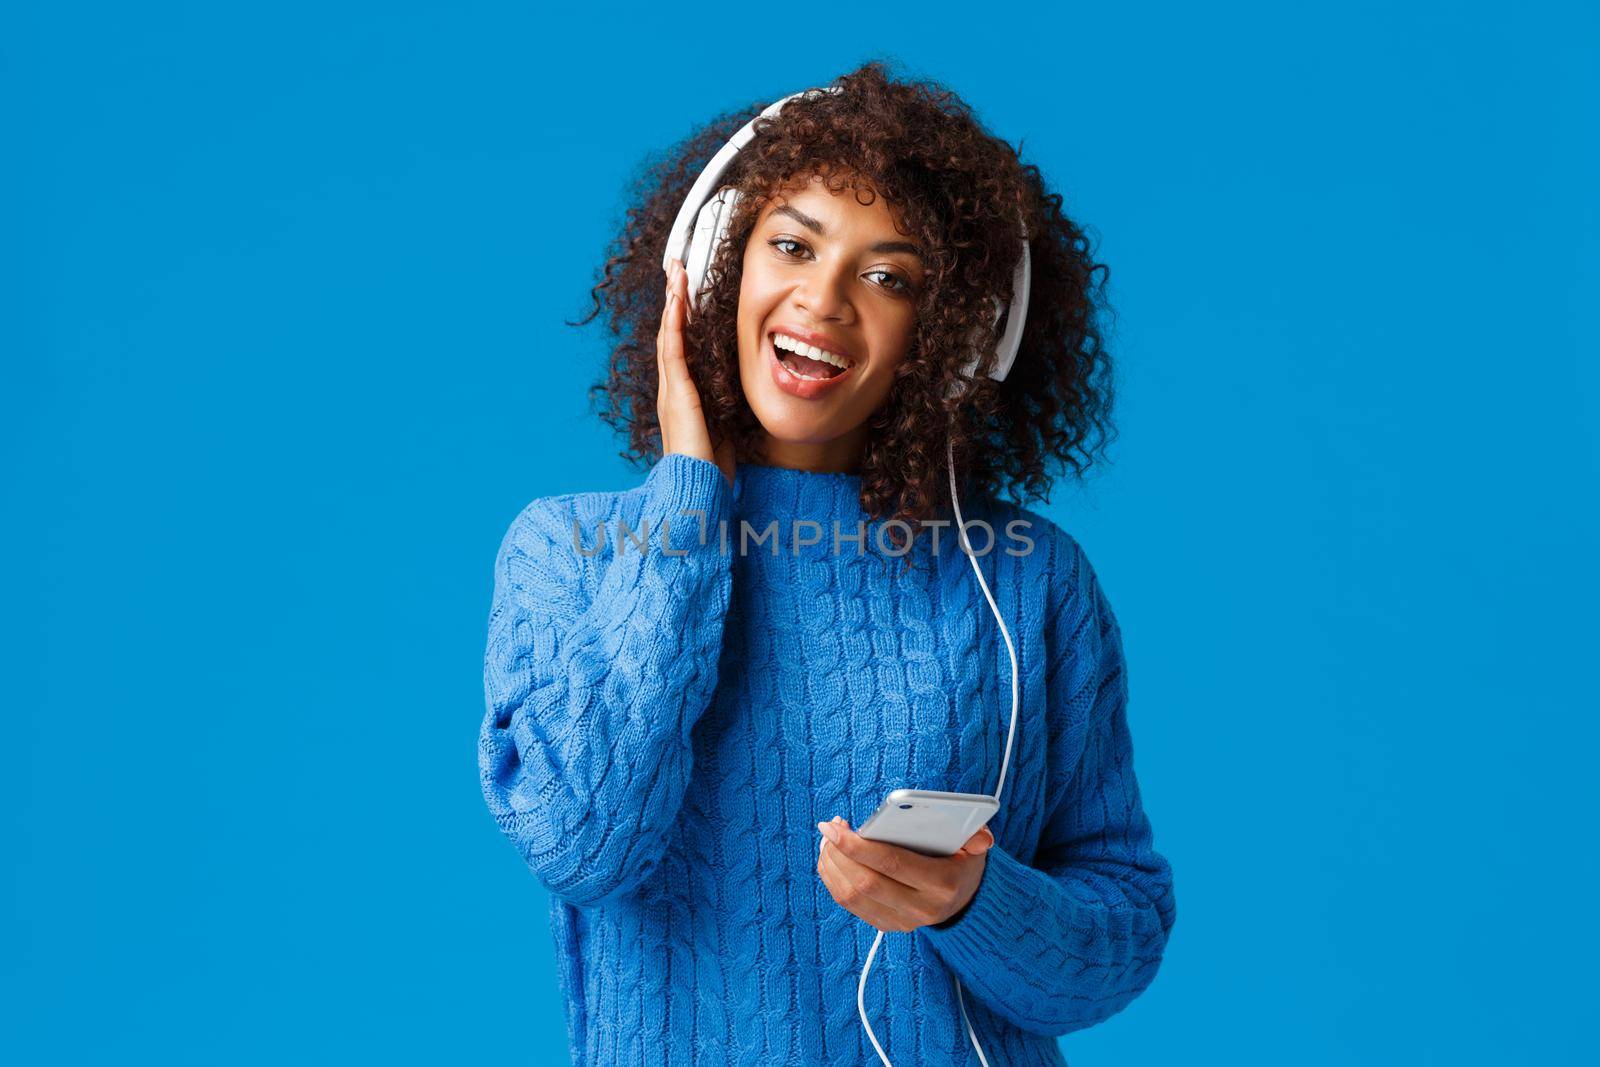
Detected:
left=0, top=3, right=1600, bottom=1067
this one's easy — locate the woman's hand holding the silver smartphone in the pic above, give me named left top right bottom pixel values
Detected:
left=816, top=817, right=995, bottom=933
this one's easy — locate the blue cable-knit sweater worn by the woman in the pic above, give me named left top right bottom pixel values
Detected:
left=478, top=454, right=1176, bottom=1067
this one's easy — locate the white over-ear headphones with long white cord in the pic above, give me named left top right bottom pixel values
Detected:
left=661, top=85, right=1034, bottom=1067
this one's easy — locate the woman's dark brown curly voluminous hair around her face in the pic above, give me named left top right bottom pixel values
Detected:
left=568, top=61, right=1115, bottom=530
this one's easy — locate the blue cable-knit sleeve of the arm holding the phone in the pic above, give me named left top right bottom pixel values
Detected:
left=920, top=537, right=1176, bottom=1037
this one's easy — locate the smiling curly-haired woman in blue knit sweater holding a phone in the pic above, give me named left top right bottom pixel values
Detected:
left=478, top=62, right=1176, bottom=1067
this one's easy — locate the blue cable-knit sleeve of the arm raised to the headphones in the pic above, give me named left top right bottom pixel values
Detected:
left=478, top=453, right=731, bottom=904
